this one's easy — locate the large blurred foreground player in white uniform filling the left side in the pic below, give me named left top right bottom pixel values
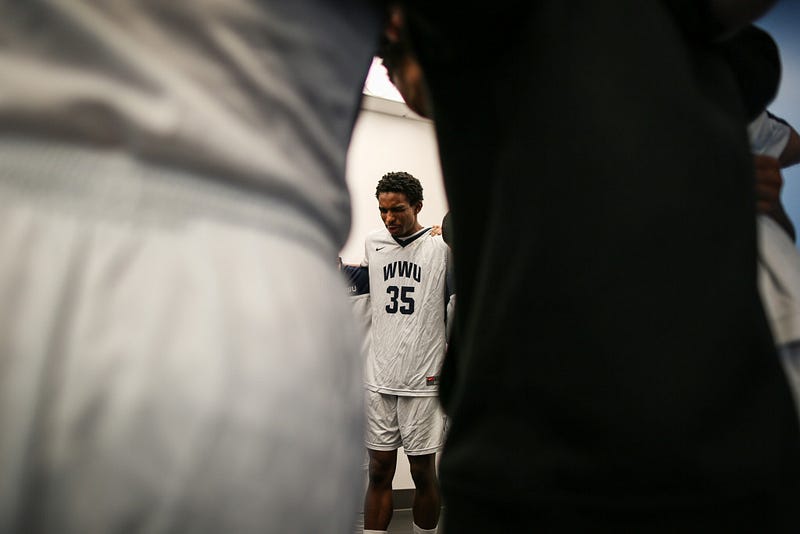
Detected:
left=0, top=0, right=380, bottom=534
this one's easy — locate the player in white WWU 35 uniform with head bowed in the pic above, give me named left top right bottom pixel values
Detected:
left=363, top=172, right=448, bottom=533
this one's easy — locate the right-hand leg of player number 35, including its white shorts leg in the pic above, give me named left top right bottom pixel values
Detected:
left=397, top=397, right=445, bottom=530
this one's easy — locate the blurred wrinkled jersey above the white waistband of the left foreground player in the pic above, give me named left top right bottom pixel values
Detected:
left=0, top=0, right=379, bottom=251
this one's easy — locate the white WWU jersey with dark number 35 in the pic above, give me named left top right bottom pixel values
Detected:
left=364, top=228, right=448, bottom=396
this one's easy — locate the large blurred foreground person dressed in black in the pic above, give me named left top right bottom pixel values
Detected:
left=404, top=0, right=800, bottom=534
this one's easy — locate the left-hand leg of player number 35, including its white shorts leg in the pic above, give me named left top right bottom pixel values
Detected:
left=364, top=391, right=402, bottom=531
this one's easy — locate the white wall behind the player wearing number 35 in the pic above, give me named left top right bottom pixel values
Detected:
left=340, top=96, right=447, bottom=489
